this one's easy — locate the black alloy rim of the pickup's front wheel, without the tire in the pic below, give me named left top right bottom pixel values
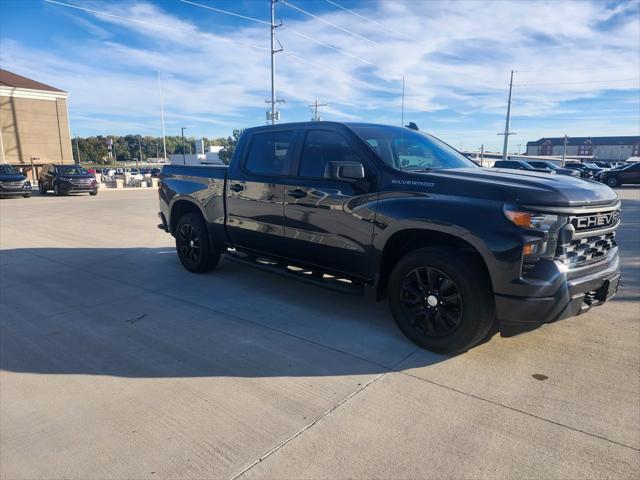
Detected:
left=400, top=267, right=463, bottom=338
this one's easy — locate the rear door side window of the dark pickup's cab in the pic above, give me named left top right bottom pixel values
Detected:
left=245, top=131, right=295, bottom=175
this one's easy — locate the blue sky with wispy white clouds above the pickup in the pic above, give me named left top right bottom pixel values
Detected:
left=0, top=0, right=640, bottom=150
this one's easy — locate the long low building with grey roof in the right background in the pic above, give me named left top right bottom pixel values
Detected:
left=527, top=136, right=640, bottom=162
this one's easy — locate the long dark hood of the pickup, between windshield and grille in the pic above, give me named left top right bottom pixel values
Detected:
left=416, top=168, right=618, bottom=207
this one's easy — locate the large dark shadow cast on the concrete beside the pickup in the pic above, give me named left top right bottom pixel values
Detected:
left=0, top=248, right=449, bottom=378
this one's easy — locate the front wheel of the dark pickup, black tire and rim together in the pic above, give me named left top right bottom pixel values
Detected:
left=388, top=247, right=495, bottom=353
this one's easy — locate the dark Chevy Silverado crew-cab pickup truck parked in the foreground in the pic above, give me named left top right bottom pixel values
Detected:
left=159, top=122, right=620, bottom=352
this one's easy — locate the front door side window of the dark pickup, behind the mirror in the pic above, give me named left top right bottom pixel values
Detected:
left=300, top=130, right=362, bottom=178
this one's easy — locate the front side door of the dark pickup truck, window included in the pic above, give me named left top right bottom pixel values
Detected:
left=284, top=128, right=377, bottom=278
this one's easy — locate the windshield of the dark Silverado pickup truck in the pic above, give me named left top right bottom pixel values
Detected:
left=352, top=126, right=477, bottom=171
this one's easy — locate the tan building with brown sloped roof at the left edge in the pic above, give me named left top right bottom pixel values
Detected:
left=0, top=69, right=73, bottom=177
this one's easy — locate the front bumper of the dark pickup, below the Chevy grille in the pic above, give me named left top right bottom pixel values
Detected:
left=495, top=248, right=620, bottom=336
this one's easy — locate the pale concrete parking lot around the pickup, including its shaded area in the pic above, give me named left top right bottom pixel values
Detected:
left=0, top=188, right=640, bottom=479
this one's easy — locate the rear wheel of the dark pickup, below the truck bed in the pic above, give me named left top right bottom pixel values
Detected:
left=175, top=213, right=220, bottom=273
